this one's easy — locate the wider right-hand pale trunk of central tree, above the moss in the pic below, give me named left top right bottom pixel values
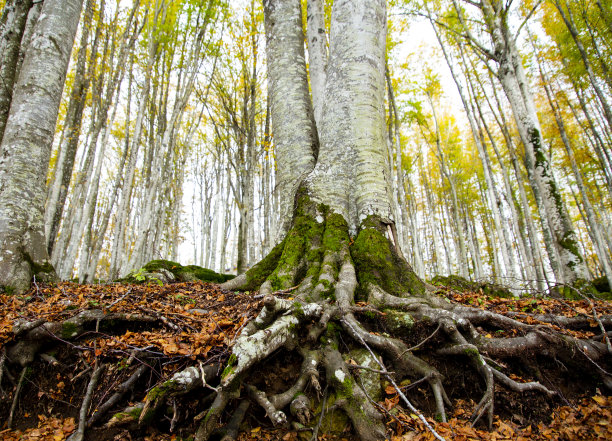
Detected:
left=306, top=0, right=392, bottom=232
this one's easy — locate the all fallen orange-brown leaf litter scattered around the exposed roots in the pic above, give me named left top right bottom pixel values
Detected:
left=0, top=282, right=612, bottom=441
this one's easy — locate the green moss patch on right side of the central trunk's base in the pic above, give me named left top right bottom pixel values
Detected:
left=351, top=216, right=425, bottom=297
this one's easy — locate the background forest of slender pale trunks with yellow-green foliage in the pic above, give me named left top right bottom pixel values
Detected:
left=0, top=0, right=612, bottom=291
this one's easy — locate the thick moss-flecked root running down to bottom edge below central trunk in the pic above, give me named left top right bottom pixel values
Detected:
left=323, top=346, right=386, bottom=441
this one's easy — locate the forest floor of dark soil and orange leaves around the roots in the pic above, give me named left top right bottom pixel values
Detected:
left=0, top=282, right=612, bottom=441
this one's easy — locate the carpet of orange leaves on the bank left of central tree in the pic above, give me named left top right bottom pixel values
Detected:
left=0, top=282, right=260, bottom=358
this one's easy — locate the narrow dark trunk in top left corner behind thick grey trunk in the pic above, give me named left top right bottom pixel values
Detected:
left=0, top=0, right=32, bottom=142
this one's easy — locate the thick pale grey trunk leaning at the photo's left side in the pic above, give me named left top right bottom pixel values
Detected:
left=0, top=0, right=82, bottom=292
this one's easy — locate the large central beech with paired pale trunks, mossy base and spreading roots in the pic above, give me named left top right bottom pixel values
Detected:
left=179, top=0, right=610, bottom=440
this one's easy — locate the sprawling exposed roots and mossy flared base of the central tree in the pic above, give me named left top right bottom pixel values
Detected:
left=0, top=207, right=612, bottom=441
